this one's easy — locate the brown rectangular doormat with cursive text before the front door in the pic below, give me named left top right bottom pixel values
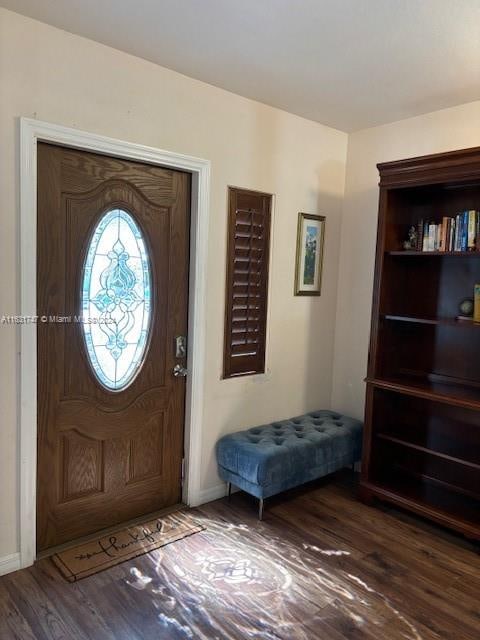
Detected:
left=52, top=511, right=205, bottom=582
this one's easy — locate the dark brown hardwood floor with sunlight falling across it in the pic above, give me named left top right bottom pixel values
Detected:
left=0, top=472, right=480, bottom=640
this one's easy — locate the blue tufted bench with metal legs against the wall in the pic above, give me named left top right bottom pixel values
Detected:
left=217, top=411, right=362, bottom=520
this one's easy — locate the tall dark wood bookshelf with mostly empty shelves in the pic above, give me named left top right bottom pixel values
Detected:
left=360, top=148, right=480, bottom=540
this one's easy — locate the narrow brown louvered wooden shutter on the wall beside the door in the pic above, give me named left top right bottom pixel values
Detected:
left=223, top=188, right=272, bottom=378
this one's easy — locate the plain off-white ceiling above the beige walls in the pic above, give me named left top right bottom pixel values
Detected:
left=0, top=0, right=480, bottom=131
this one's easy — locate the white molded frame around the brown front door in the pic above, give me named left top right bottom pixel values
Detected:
left=19, top=118, right=210, bottom=567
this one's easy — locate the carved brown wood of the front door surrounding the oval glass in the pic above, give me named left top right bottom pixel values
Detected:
left=37, top=143, right=190, bottom=550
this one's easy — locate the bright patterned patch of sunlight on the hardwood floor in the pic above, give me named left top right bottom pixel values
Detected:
left=126, top=517, right=422, bottom=640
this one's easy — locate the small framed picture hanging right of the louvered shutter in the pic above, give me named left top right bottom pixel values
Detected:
left=295, top=213, right=325, bottom=296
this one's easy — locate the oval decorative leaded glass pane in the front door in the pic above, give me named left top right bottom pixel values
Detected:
left=82, top=209, right=151, bottom=391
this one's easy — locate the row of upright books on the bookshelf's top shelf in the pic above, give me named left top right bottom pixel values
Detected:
left=410, top=209, right=480, bottom=253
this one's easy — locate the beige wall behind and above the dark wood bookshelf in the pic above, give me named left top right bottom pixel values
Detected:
left=332, top=102, right=480, bottom=417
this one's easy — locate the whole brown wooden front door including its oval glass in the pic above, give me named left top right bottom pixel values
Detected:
left=37, top=143, right=190, bottom=550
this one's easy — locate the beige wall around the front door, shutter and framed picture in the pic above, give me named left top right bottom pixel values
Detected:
left=0, top=10, right=347, bottom=557
